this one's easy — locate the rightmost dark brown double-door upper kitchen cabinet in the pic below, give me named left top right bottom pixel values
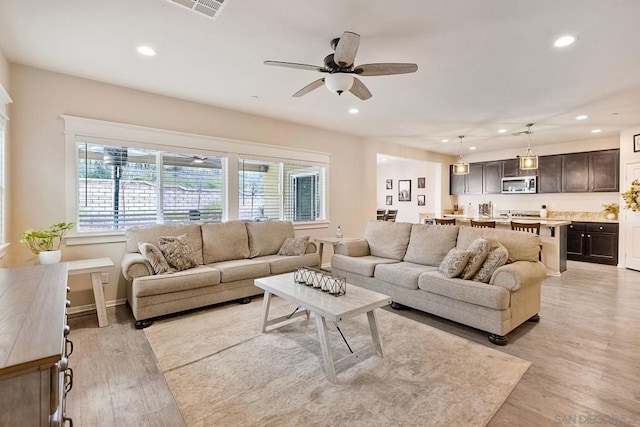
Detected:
left=562, top=150, right=620, bottom=193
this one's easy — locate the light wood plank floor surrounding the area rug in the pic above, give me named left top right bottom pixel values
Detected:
left=67, top=262, right=640, bottom=426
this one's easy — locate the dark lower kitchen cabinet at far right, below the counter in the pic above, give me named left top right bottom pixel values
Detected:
left=567, top=222, right=618, bottom=265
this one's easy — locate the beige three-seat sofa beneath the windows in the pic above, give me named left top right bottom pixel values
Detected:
left=122, top=221, right=320, bottom=328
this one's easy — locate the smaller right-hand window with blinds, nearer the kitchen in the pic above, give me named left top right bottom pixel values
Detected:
left=238, top=158, right=326, bottom=222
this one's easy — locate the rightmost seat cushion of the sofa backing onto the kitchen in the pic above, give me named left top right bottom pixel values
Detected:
left=418, top=272, right=511, bottom=310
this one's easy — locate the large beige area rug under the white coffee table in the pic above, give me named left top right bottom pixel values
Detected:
left=145, top=298, right=530, bottom=426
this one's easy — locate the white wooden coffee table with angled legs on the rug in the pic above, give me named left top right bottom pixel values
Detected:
left=254, top=273, right=391, bottom=383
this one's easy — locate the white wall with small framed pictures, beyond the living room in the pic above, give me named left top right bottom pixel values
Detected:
left=376, top=156, right=446, bottom=223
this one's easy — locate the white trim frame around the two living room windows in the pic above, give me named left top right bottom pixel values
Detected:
left=61, top=115, right=331, bottom=245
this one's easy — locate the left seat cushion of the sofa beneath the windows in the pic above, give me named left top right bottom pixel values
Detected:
left=132, top=266, right=220, bottom=298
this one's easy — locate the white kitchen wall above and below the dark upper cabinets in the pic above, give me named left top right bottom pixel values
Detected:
left=458, top=136, right=623, bottom=216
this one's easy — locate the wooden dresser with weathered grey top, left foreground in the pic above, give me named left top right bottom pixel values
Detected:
left=0, top=263, right=73, bottom=427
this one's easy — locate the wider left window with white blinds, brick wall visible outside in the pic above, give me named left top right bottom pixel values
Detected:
left=76, top=142, right=224, bottom=233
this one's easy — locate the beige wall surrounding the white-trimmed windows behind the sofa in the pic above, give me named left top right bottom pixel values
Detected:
left=8, top=64, right=384, bottom=306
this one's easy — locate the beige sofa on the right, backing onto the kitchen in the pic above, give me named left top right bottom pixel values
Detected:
left=331, top=221, right=546, bottom=345
